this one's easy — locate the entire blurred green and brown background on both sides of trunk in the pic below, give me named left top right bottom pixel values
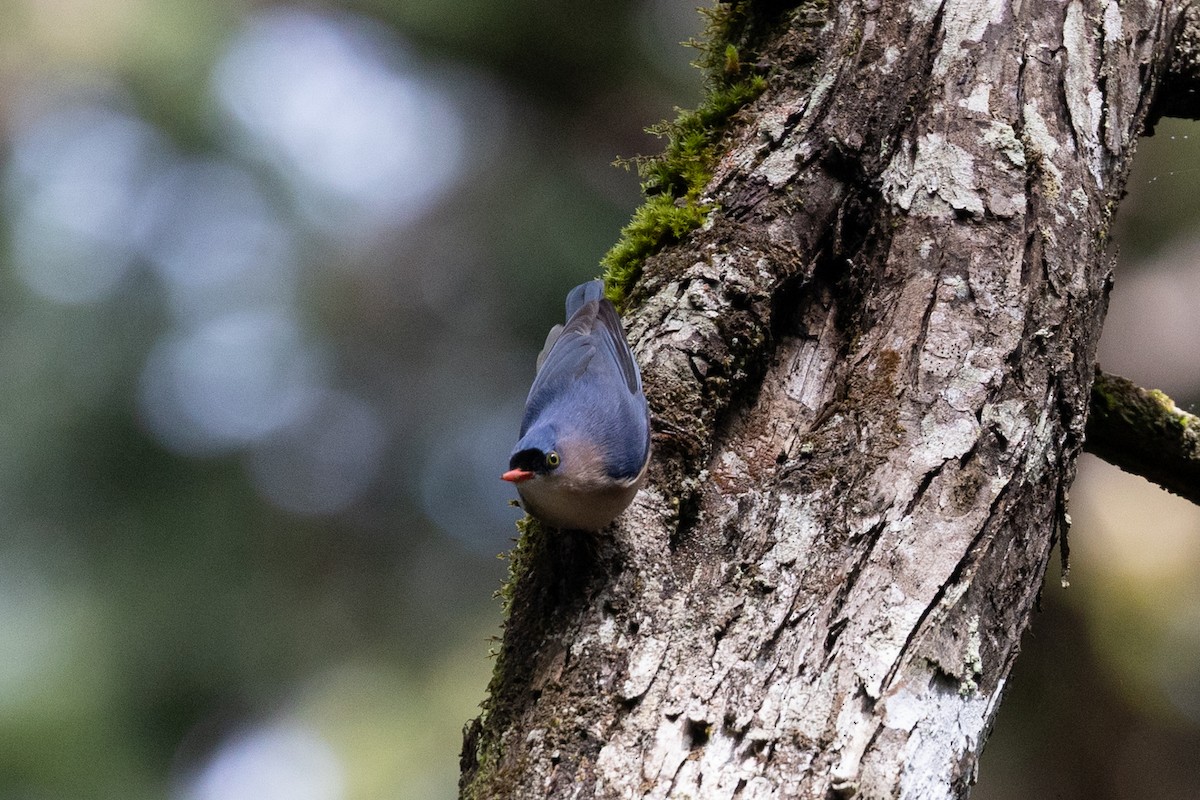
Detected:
left=0, top=0, right=1200, bottom=800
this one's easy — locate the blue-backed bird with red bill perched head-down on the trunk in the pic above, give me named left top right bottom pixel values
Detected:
left=500, top=281, right=650, bottom=531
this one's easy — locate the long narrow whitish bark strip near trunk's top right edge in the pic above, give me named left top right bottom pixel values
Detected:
left=1062, top=0, right=1099, bottom=184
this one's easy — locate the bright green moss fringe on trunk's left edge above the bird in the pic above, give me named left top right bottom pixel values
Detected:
left=600, top=1, right=767, bottom=306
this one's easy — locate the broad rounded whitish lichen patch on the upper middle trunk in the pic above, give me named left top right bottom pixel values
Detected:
left=882, top=133, right=984, bottom=219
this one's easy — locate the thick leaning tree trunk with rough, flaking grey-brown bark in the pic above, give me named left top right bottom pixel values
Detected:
left=463, top=0, right=1182, bottom=799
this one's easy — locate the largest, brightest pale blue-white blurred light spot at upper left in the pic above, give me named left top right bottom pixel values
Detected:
left=215, top=8, right=464, bottom=235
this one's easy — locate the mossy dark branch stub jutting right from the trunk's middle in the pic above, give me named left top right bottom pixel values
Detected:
left=1084, top=369, right=1200, bottom=504
